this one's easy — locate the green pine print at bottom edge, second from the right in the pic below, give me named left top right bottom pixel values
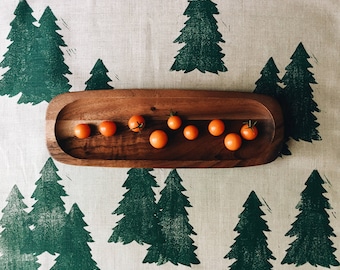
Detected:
left=224, top=191, right=275, bottom=270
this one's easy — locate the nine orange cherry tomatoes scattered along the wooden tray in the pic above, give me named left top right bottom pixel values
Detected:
left=74, top=112, right=258, bottom=151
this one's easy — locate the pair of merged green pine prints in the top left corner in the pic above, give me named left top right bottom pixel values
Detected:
left=0, top=3, right=71, bottom=105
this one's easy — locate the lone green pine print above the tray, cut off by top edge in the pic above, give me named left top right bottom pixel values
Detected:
left=171, top=0, right=227, bottom=74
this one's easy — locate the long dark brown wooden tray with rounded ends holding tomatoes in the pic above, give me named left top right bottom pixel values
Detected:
left=46, top=89, right=284, bottom=168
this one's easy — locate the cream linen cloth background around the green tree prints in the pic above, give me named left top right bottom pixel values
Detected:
left=0, top=0, right=340, bottom=270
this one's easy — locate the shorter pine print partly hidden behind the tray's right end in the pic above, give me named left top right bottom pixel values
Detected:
left=254, top=57, right=292, bottom=155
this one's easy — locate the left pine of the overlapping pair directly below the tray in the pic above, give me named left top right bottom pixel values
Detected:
left=108, top=168, right=159, bottom=244
